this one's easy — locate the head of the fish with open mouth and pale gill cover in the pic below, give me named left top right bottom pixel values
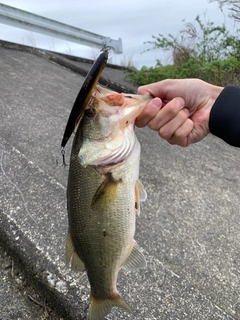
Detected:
left=79, top=85, right=151, bottom=167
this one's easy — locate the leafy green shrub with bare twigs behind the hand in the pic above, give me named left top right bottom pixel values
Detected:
left=127, top=16, right=240, bottom=86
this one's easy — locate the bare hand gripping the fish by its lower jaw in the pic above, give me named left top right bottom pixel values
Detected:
left=135, top=79, right=223, bottom=147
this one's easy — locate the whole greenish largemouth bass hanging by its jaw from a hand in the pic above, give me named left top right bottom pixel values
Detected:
left=66, top=84, right=152, bottom=320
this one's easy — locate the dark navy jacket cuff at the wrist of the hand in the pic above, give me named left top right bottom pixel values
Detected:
left=209, top=85, right=240, bottom=147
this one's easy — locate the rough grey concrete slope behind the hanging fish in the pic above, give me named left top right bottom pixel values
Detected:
left=0, top=42, right=240, bottom=320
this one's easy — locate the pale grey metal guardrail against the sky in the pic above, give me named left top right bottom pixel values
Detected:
left=0, top=3, right=122, bottom=53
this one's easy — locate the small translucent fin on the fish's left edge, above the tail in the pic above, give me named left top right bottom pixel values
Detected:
left=66, top=230, right=85, bottom=271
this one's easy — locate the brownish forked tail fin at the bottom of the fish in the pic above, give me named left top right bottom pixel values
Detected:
left=89, top=294, right=132, bottom=320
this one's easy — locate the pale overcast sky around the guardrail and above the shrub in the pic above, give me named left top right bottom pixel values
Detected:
left=0, top=0, right=232, bottom=69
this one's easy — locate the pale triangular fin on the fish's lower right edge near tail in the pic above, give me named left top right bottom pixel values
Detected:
left=123, top=240, right=147, bottom=270
